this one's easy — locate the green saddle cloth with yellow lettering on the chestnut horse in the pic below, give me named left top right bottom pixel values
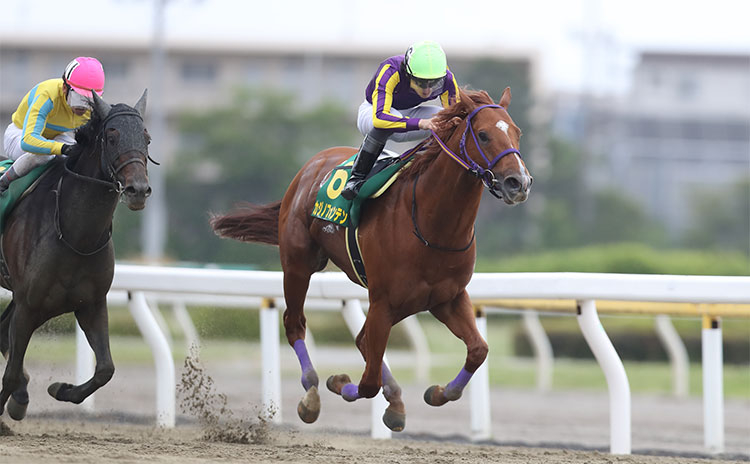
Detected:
left=311, top=155, right=412, bottom=227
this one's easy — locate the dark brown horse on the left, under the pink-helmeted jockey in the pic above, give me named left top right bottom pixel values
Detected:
left=0, top=92, right=151, bottom=420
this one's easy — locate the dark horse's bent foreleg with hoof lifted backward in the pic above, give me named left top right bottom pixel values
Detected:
left=47, top=301, right=115, bottom=404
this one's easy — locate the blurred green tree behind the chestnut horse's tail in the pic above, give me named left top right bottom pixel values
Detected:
left=111, top=89, right=359, bottom=268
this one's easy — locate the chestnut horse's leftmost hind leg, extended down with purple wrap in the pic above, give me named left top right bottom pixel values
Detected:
left=284, top=271, right=320, bottom=424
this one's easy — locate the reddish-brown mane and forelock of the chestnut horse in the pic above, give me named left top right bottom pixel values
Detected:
left=401, top=88, right=494, bottom=179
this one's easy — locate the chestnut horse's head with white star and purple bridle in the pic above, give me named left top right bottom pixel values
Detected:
left=443, top=87, right=533, bottom=205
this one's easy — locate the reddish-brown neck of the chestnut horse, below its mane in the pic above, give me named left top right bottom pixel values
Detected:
left=410, top=147, right=482, bottom=236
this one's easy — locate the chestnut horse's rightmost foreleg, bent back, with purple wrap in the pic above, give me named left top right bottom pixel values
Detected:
left=424, top=291, right=488, bottom=406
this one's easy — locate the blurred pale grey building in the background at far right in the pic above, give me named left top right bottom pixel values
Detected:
left=554, top=51, right=750, bottom=236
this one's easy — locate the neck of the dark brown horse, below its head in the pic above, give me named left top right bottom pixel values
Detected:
left=57, top=153, right=118, bottom=249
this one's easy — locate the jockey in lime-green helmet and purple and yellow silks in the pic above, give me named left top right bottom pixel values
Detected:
left=341, top=40, right=458, bottom=200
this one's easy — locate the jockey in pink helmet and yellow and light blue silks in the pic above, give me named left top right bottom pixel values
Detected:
left=0, top=56, right=104, bottom=194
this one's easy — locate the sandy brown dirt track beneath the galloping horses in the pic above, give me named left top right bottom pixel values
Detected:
left=0, top=356, right=750, bottom=464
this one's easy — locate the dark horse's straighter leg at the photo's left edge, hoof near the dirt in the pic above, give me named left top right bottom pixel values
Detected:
left=0, top=301, right=39, bottom=420
